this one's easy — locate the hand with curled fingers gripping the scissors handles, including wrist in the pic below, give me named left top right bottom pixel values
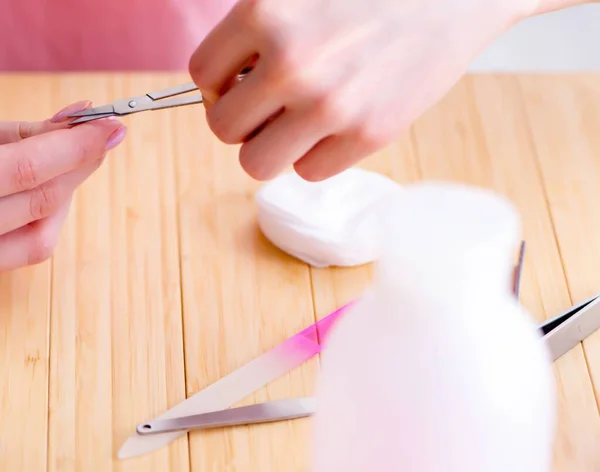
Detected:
left=190, top=0, right=540, bottom=180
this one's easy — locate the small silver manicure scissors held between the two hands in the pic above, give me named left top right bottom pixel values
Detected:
left=69, top=67, right=252, bottom=126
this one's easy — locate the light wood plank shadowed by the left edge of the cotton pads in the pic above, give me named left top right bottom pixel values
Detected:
left=171, top=88, right=317, bottom=472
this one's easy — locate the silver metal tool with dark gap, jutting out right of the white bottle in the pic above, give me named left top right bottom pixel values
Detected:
left=539, top=294, right=600, bottom=361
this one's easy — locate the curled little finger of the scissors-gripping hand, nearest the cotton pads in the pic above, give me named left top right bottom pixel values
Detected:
left=294, top=134, right=381, bottom=182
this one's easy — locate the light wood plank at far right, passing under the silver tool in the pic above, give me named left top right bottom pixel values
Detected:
left=519, top=76, right=600, bottom=471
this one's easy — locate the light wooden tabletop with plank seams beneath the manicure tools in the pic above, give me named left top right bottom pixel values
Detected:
left=0, top=74, right=600, bottom=472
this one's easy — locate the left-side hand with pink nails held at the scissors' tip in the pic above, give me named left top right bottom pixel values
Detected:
left=0, top=102, right=126, bottom=272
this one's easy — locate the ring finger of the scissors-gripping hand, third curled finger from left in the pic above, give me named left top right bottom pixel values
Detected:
left=240, top=109, right=326, bottom=180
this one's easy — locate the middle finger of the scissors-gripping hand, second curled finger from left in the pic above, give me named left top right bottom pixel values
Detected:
left=206, top=62, right=283, bottom=144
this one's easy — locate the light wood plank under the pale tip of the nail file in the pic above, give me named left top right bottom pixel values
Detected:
left=48, top=78, right=188, bottom=472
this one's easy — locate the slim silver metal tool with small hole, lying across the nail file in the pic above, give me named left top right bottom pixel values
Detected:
left=136, top=397, right=316, bottom=436
